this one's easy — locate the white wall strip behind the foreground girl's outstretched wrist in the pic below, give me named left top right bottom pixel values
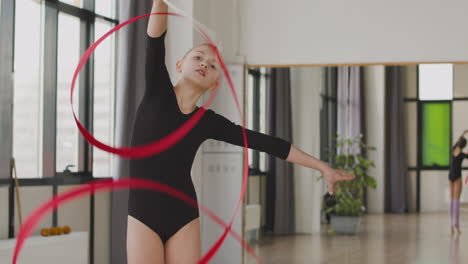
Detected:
left=291, top=67, right=324, bottom=234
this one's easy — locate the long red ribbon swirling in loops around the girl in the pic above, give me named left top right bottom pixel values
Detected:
left=13, top=12, right=261, bottom=264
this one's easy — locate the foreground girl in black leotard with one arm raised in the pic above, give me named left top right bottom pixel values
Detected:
left=127, top=0, right=354, bottom=264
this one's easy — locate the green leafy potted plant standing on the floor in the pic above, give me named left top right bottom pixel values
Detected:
left=321, top=135, right=377, bottom=234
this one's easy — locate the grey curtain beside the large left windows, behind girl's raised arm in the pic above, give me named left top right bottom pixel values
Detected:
left=111, top=0, right=152, bottom=264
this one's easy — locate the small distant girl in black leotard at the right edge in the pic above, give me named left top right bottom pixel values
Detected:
left=449, top=130, right=468, bottom=235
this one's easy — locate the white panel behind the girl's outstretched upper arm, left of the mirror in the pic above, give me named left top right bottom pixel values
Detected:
left=198, top=65, right=244, bottom=264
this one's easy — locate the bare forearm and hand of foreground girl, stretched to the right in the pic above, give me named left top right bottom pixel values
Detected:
left=286, top=145, right=355, bottom=194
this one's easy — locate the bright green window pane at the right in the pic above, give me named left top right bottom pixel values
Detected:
left=422, top=103, right=451, bottom=166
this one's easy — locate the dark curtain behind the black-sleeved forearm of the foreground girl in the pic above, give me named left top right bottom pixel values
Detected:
left=266, top=68, right=295, bottom=234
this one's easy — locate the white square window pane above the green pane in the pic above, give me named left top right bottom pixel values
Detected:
left=419, top=64, right=453, bottom=100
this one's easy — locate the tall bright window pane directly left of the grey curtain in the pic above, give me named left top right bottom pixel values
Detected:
left=93, top=20, right=115, bottom=177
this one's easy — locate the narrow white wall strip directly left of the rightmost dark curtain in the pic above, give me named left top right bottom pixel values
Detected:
left=364, top=66, right=385, bottom=213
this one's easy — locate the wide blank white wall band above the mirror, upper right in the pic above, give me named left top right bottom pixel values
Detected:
left=239, top=0, right=468, bottom=64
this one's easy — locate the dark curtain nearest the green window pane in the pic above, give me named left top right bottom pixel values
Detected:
left=385, top=66, right=409, bottom=213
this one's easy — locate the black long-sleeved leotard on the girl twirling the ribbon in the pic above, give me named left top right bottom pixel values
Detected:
left=128, top=32, right=291, bottom=243
